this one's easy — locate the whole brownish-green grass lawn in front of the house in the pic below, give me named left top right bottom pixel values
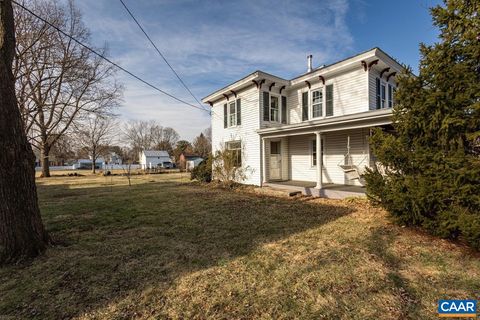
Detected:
left=0, top=174, right=480, bottom=319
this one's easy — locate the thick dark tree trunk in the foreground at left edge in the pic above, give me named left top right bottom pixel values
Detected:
left=0, top=0, right=48, bottom=264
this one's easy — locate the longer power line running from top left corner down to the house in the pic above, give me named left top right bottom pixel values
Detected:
left=12, top=0, right=209, bottom=112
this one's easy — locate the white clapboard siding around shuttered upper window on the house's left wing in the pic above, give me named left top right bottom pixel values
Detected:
left=212, top=85, right=261, bottom=185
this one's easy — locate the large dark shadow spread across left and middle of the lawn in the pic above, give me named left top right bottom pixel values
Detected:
left=0, top=182, right=354, bottom=319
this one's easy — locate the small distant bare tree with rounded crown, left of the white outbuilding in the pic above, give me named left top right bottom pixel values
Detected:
left=76, top=115, right=117, bottom=173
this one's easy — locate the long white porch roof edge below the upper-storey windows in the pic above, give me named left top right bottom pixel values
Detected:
left=257, top=109, right=392, bottom=137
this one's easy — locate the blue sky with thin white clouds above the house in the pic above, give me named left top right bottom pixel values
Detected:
left=77, top=0, right=440, bottom=140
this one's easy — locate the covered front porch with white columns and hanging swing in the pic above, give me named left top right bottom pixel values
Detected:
left=259, top=111, right=389, bottom=199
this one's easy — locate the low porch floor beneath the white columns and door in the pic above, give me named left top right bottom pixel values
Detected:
left=263, top=180, right=365, bottom=199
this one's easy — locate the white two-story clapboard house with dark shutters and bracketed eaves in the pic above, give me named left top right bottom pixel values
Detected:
left=203, top=48, right=403, bottom=196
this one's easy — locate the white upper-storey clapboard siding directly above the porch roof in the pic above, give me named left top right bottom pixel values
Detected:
left=287, top=67, right=369, bottom=124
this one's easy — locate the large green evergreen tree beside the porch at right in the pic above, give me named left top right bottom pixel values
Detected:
left=365, top=0, right=480, bottom=248
